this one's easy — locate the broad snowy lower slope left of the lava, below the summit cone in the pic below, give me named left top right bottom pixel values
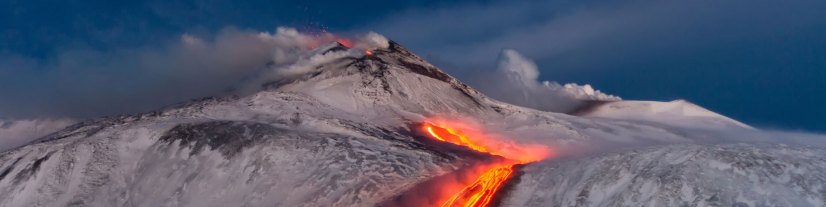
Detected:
left=0, top=92, right=470, bottom=206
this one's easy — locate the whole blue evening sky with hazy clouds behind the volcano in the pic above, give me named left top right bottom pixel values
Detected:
left=0, top=0, right=826, bottom=132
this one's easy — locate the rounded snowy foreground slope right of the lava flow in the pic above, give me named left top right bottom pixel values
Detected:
left=503, top=144, right=826, bottom=207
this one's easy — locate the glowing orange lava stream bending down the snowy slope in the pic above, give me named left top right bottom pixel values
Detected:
left=422, top=122, right=549, bottom=207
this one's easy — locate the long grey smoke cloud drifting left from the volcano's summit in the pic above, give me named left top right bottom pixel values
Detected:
left=0, top=28, right=387, bottom=119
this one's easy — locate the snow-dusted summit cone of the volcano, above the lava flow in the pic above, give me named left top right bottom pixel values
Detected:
left=274, top=42, right=492, bottom=117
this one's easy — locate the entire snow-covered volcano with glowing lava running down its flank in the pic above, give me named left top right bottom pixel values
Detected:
left=0, top=38, right=826, bottom=206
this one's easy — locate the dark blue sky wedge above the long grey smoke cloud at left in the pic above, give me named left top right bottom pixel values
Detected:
left=0, top=0, right=458, bottom=57
